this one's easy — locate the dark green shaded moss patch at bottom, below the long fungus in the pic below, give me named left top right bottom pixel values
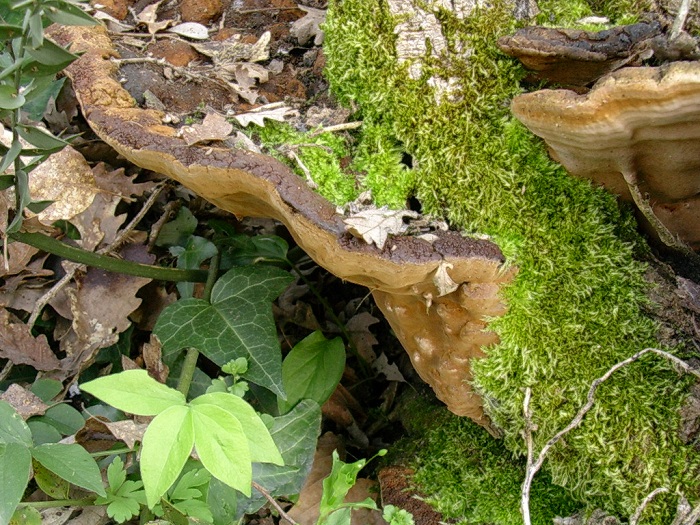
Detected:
left=391, top=393, right=581, bottom=525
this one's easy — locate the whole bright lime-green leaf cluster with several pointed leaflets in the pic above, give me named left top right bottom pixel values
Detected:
left=81, top=370, right=283, bottom=508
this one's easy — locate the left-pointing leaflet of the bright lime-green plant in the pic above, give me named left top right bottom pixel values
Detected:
left=80, top=366, right=185, bottom=416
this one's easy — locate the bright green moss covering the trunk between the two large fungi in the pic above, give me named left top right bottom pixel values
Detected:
left=325, top=0, right=700, bottom=523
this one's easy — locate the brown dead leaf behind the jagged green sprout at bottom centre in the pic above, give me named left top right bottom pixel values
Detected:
left=282, top=432, right=386, bottom=525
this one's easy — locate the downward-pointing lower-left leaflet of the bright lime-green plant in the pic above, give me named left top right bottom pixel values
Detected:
left=141, top=405, right=194, bottom=508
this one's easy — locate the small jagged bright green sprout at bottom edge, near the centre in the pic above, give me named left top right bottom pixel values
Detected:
left=316, top=450, right=386, bottom=525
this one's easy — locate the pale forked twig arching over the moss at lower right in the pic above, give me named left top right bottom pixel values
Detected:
left=521, top=348, right=700, bottom=525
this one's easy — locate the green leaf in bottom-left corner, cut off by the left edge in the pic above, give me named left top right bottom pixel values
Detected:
left=0, top=442, right=32, bottom=525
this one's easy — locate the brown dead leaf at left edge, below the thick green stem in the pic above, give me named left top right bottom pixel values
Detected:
left=0, top=308, right=61, bottom=371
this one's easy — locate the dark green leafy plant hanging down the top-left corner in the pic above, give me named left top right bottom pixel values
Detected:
left=0, top=0, right=95, bottom=233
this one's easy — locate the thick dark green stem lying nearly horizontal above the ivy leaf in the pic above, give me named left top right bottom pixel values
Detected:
left=9, top=232, right=209, bottom=283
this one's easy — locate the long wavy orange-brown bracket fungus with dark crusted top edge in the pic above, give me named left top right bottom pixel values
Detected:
left=45, top=27, right=515, bottom=428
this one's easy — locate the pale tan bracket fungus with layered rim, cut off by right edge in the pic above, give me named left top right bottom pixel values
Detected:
left=511, top=62, right=700, bottom=251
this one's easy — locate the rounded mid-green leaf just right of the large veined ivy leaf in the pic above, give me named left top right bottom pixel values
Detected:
left=278, top=331, right=345, bottom=413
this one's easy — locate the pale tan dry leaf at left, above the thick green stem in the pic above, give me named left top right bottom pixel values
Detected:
left=29, top=146, right=99, bottom=225
